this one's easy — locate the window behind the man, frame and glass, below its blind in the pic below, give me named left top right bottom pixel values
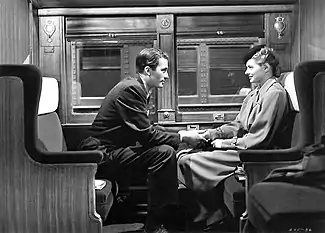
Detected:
left=63, top=40, right=154, bottom=123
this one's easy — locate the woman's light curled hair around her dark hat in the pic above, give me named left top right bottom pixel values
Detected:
left=251, top=46, right=281, bottom=77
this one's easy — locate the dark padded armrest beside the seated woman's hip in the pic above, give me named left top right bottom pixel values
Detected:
left=238, top=148, right=303, bottom=163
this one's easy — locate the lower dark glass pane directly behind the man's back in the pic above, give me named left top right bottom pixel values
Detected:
left=79, top=69, right=121, bottom=97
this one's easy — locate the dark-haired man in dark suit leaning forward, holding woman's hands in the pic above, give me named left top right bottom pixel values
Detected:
left=81, top=48, right=204, bottom=233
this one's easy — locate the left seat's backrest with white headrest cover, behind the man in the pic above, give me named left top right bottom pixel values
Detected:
left=38, top=77, right=67, bottom=152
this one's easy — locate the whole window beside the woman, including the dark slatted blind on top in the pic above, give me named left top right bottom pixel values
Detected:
left=176, top=13, right=265, bottom=123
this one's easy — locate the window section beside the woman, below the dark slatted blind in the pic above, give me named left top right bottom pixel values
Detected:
left=177, top=38, right=257, bottom=122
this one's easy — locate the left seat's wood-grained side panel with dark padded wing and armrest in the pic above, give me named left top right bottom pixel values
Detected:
left=0, top=65, right=102, bottom=233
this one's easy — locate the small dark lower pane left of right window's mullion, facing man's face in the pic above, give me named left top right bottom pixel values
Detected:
left=178, top=71, right=197, bottom=95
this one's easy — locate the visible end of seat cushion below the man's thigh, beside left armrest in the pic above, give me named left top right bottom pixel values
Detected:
left=95, top=180, right=114, bottom=221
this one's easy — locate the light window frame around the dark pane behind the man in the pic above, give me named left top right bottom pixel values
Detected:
left=64, top=38, right=156, bottom=124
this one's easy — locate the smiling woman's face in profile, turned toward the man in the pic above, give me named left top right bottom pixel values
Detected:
left=245, top=59, right=267, bottom=83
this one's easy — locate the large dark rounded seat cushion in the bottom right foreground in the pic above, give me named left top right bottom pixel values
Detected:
left=247, top=182, right=325, bottom=231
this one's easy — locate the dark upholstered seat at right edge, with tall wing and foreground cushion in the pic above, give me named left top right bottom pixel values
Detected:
left=241, top=61, right=325, bottom=232
